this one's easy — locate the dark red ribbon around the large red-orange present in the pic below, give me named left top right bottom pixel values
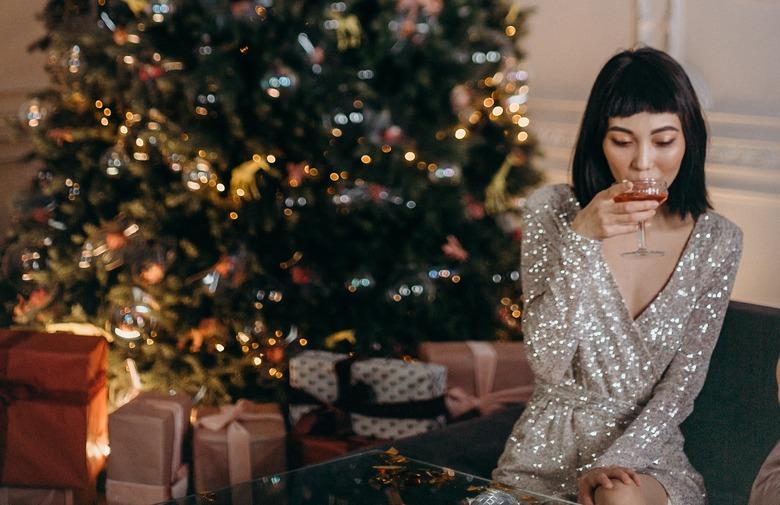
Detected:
left=0, top=331, right=106, bottom=477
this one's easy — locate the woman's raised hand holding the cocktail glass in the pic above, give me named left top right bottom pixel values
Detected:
left=571, top=181, right=658, bottom=240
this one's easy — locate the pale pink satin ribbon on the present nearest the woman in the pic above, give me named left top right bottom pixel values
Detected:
left=445, top=341, right=534, bottom=418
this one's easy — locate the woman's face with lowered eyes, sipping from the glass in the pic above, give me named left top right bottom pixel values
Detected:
left=603, top=112, right=685, bottom=186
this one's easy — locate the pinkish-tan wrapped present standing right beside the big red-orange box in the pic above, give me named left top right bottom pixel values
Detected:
left=107, top=392, right=192, bottom=505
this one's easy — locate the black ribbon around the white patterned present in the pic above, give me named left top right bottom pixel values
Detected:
left=288, top=356, right=447, bottom=435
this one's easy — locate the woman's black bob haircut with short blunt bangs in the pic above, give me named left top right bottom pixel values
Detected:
left=572, top=47, right=712, bottom=218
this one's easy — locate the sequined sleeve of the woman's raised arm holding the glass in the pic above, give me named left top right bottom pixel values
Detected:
left=520, top=187, right=601, bottom=383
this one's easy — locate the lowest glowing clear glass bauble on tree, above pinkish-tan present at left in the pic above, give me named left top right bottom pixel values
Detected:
left=109, top=287, right=160, bottom=341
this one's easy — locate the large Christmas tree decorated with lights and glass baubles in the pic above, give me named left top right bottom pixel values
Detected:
left=2, top=0, right=539, bottom=401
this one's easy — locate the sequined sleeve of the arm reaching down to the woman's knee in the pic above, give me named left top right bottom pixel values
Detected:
left=592, top=222, right=742, bottom=468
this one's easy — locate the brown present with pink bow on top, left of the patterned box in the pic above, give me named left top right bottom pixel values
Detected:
left=193, top=400, right=287, bottom=493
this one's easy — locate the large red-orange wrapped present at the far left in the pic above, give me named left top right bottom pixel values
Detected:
left=0, top=330, right=108, bottom=489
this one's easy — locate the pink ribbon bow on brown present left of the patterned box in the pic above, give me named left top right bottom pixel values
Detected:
left=197, top=400, right=284, bottom=485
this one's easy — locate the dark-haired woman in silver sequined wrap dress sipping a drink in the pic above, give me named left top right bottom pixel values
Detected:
left=493, top=48, right=742, bottom=505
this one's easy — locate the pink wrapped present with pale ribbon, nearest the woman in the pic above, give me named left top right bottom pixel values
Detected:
left=419, top=341, right=534, bottom=418
